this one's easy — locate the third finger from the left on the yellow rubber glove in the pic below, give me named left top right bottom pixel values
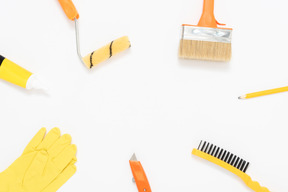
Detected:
left=48, top=134, right=72, bottom=158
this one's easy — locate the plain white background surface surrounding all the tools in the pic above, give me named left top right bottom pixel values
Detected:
left=0, top=0, right=288, bottom=192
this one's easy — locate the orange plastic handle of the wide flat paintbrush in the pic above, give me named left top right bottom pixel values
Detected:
left=198, top=0, right=225, bottom=28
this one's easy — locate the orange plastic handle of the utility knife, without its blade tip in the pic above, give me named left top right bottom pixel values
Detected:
left=129, top=161, right=151, bottom=192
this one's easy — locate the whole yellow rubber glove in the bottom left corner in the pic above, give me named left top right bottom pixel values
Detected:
left=0, top=128, right=77, bottom=192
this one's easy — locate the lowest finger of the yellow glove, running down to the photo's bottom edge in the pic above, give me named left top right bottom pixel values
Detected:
left=41, top=162, right=77, bottom=192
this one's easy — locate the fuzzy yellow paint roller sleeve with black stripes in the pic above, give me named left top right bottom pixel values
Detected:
left=83, top=36, right=131, bottom=68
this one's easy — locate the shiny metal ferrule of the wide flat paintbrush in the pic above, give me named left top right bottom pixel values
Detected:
left=182, top=25, right=232, bottom=43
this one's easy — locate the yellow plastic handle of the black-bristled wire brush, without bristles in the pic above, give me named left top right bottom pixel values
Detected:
left=192, top=149, right=270, bottom=192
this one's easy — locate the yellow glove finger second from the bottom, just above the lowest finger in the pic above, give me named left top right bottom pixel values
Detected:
left=53, top=145, right=77, bottom=170
